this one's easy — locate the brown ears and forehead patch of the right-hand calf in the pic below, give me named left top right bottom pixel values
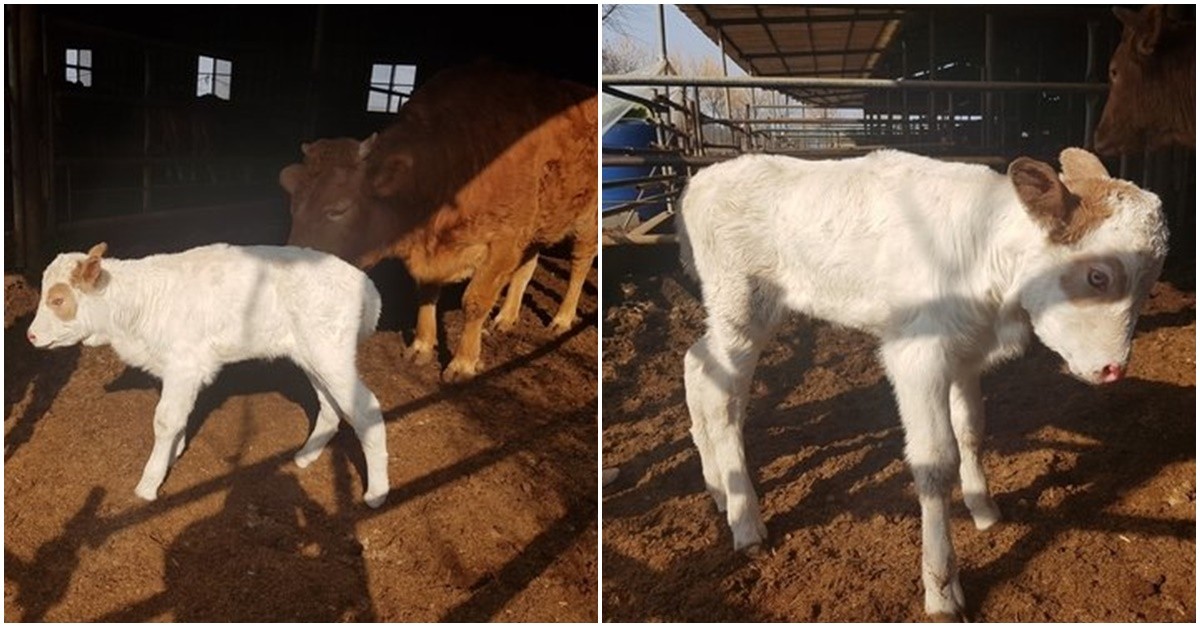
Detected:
left=1008, top=148, right=1123, bottom=246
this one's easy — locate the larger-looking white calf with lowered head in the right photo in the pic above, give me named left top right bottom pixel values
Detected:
left=679, top=149, right=1166, bottom=615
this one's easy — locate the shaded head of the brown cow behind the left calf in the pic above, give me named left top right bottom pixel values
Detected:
left=280, top=136, right=412, bottom=267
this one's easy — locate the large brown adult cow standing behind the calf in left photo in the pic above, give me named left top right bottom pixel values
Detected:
left=280, top=64, right=598, bottom=381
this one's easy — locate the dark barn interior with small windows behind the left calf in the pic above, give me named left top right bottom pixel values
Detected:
left=5, top=5, right=595, bottom=270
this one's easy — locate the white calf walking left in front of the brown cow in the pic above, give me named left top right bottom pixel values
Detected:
left=29, top=244, right=388, bottom=507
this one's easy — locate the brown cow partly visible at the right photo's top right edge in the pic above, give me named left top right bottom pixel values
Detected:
left=1096, top=5, right=1196, bottom=155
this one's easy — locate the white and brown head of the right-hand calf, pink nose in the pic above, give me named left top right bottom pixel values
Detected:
left=1008, top=148, right=1168, bottom=383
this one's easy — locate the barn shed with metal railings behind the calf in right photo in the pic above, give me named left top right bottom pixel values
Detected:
left=602, top=5, right=1195, bottom=275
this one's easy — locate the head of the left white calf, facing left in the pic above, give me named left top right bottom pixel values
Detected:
left=26, top=244, right=108, bottom=348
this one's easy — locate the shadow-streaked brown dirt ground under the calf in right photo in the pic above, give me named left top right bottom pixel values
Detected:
left=601, top=249, right=1196, bottom=622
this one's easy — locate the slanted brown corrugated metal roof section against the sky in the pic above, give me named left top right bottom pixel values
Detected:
left=678, top=5, right=905, bottom=106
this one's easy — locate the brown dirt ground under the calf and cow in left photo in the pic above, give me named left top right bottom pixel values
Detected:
left=4, top=251, right=598, bottom=622
